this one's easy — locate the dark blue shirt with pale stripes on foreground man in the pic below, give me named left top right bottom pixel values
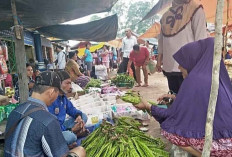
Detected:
left=4, top=98, right=69, bottom=157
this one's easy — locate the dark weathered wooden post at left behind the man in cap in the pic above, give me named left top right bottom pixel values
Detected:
left=11, top=0, right=28, bottom=102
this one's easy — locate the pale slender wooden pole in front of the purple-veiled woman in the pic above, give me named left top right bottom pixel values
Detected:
left=202, top=0, right=224, bottom=157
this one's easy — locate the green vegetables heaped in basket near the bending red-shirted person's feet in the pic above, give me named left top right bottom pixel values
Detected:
left=111, top=74, right=135, bottom=88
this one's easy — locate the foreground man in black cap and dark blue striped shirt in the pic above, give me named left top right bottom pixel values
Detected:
left=4, top=72, right=85, bottom=157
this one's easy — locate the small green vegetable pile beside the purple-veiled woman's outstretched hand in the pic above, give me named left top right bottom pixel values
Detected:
left=121, top=91, right=141, bottom=105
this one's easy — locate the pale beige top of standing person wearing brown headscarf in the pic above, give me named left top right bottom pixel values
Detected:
left=158, top=8, right=207, bottom=72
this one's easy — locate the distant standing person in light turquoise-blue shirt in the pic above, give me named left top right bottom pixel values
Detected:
left=84, top=43, right=93, bottom=77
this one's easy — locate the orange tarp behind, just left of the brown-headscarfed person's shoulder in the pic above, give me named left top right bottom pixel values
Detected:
left=139, top=22, right=161, bottom=39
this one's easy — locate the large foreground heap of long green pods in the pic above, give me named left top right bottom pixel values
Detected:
left=82, top=117, right=169, bottom=157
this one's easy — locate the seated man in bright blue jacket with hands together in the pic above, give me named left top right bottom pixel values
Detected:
left=48, top=70, right=87, bottom=146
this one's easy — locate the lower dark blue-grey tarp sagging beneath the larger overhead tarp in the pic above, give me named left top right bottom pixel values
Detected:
left=37, top=14, right=118, bottom=42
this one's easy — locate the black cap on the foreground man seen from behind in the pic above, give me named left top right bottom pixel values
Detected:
left=35, top=71, right=62, bottom=91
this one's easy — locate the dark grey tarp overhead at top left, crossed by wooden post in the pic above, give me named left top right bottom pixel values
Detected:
left=0, top=0, right=117, bottom=30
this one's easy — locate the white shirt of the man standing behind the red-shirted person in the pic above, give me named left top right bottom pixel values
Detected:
left=122, top=36, right=137, bottom=58
